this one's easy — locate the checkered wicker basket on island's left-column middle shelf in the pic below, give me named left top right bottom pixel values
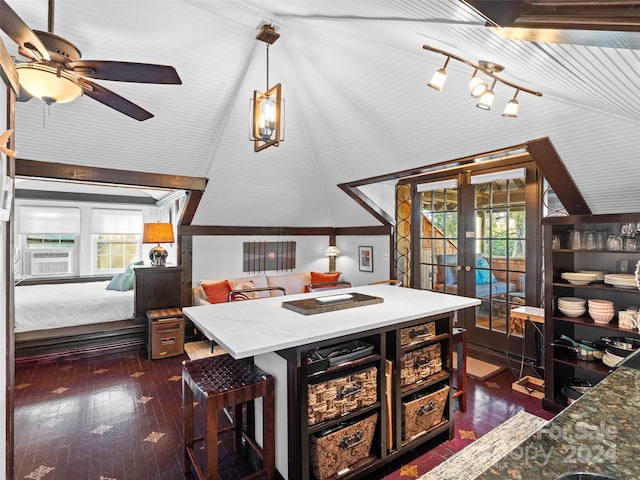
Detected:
left=308, top=367, right=378, bottom=425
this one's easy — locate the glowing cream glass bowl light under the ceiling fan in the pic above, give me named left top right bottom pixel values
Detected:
left=16, top=63, right=82, bottom=104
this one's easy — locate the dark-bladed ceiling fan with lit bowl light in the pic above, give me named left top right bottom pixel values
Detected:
left=0, top=0, right=182, bottom=121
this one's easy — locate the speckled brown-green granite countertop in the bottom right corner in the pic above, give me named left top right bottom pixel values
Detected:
left=477, top=351, right=640, bottom=480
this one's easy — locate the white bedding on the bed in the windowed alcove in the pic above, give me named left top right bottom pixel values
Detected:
left=15, top=281, right=134, bottom=333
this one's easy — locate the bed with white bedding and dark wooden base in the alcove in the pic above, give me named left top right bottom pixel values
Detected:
left=14, top=281, right=146, bottom=363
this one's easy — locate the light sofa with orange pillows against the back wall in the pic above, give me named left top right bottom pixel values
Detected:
left=193, top=272, right=340, bottom=305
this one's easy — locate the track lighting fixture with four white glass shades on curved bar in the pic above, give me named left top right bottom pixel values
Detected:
left=422, top=45, right=542, bottom=118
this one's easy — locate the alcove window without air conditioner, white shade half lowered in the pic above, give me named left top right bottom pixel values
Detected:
left=91, top=208, right=143, bottom=273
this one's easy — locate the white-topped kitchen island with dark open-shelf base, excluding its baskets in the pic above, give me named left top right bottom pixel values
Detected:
left=183, top=285, right=480, bottom=480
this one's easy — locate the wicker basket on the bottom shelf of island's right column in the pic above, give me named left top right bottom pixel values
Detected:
left=402, top=385, right=449, bottom=441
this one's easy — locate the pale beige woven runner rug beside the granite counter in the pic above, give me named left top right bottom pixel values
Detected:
left=418, top=410, right=547, bottom=480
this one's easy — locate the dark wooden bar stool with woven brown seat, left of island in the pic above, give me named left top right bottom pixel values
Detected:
left=182, top=354, right=276, bottom=480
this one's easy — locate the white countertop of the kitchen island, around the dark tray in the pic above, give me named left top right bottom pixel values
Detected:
left=182, top=285, right=480, bottom=358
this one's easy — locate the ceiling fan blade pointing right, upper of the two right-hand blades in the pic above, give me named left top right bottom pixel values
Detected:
left=67, top=60, right=182, bottom=85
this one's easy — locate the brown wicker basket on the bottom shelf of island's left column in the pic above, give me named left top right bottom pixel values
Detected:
left=309, top=413, right=378, bottom=480
